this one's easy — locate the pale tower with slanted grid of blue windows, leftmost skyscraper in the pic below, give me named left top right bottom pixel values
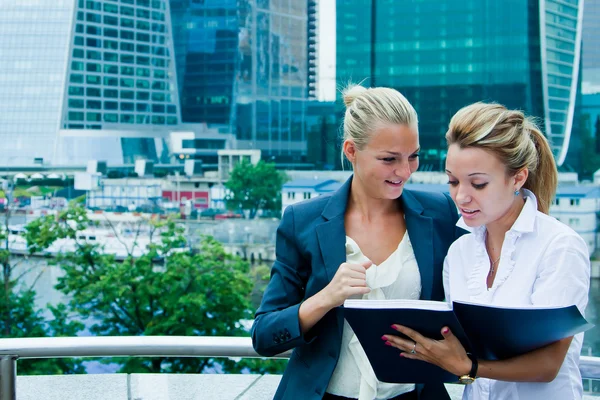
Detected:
left=0, top=0, right=180, bottom=165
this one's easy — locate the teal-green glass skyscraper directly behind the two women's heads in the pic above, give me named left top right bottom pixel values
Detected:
left=336, top=0, right=583, bottom=170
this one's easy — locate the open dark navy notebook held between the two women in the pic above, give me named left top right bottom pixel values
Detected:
left=344, top=300, right=593, bottom=383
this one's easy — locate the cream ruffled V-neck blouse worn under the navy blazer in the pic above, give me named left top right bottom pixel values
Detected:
left=327, top=233, right=421, bottom=400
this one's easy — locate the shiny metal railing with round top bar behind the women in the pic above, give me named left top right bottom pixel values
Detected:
left=0, top=336, right=600, bottom=400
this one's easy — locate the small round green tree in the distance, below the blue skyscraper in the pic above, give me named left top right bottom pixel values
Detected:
left=225, top=161, right=284, bottom=219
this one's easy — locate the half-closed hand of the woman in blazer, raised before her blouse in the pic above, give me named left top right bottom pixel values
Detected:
left=323, top=261, right=373, bottom=308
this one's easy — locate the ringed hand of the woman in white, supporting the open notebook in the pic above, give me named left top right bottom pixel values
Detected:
left=381, top=325, right=472, bottom=376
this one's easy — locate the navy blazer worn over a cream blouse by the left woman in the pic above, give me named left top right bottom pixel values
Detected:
left=252, top=178, right=463, bottom=400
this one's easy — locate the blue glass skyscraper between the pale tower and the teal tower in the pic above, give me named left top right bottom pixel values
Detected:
left=170, top=0, right=308, bottom=163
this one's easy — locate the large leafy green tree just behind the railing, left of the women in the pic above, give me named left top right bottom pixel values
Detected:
left=27, top=206, right=288, bottom=373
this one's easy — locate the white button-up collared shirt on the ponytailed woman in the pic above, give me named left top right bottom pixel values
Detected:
left=444, top=190, right=590, bottom=400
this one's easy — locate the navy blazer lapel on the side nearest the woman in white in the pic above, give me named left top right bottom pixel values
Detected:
left=401, top=189, right=435, bottom=300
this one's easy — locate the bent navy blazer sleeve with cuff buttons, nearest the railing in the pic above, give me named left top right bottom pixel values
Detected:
left=252, top=206, right=310, bottom=357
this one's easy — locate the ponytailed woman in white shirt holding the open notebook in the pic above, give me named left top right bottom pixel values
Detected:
left=385, top=103, right=590, bottom=400
